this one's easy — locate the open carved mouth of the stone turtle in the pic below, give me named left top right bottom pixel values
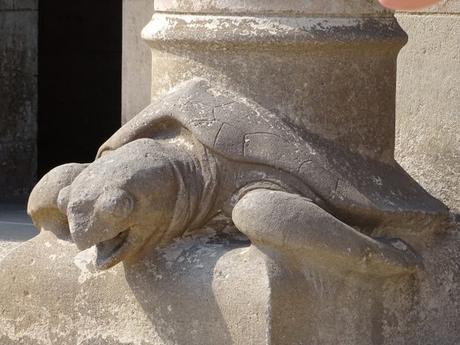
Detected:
left=96, top=229, right=132, bottom=270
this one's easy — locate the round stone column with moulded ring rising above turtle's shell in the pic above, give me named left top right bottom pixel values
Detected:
left=143, top=0, right=406, bottom=160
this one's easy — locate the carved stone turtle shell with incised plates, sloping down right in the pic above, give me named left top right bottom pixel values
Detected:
left=98, top=79, right=449, bottom=227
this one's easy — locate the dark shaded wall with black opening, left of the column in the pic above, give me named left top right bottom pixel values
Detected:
left=0, top=0, right=123, bottom=202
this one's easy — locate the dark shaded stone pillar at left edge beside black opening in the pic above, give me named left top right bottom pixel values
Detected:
left=0, top=0, right=38, bottom=201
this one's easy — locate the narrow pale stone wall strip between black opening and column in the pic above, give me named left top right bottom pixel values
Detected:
left=121, top=0, right=153, bottom=123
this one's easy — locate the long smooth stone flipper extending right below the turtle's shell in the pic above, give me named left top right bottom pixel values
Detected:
left=232, top=189, right=420, bottom=276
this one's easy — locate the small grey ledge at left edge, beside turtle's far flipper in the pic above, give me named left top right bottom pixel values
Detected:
left=0, top=204, right=37, bottom=260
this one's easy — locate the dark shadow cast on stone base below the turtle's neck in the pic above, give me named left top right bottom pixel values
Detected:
left=125, top=220, right=249, bottom=345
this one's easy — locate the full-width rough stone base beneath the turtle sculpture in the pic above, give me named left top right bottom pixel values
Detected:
left=0, top=219, right=460, bottom=345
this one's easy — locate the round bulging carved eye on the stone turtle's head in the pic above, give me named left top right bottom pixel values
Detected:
left=97, top=189, right=134, bottom=218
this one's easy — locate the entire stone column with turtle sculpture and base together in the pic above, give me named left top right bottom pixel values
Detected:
left=0, top=0, right=460, bottom=345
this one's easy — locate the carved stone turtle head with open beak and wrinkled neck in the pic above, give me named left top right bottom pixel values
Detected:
left=58, top=139, right=181, bottom=269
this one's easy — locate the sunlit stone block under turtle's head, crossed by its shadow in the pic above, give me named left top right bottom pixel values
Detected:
left=0, top=223, right=269, bottom=345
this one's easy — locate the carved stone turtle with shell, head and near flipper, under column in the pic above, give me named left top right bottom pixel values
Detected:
left=28, top=79, right=449, bottom=275
